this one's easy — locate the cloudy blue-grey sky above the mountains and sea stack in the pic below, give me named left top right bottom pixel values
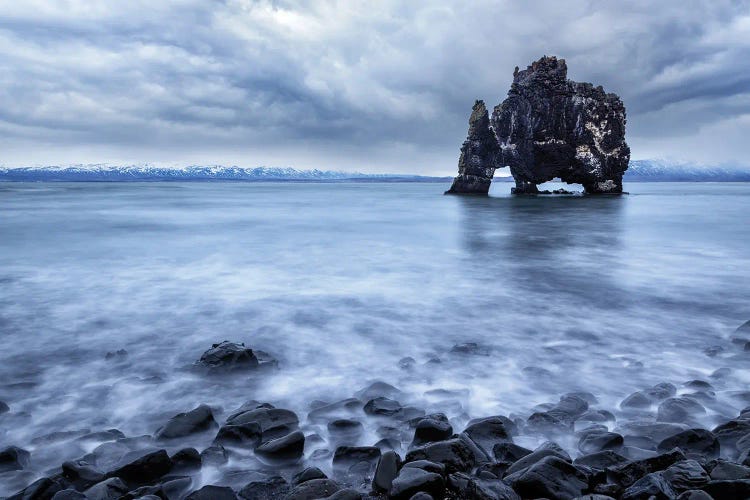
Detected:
left=0, top=0, right=750, bottom=175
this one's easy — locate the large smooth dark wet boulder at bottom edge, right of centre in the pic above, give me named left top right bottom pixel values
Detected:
left=511, top=456, right=588, bottom=499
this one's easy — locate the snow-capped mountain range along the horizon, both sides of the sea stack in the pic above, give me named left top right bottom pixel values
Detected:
left=0, top=160, right=750, bottom=182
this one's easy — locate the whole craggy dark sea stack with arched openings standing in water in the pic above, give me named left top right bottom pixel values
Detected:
left=448, top=56, right=630, bottom=194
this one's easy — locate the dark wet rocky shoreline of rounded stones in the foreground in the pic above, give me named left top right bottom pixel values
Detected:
left=0, top=322, right=750, bottom=500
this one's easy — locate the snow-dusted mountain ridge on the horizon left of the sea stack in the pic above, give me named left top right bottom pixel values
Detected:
left=0, top=164, right=450, bottom=182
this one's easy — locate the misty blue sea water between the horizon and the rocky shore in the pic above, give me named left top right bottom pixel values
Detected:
left=0, top=183, right=750, bottom=494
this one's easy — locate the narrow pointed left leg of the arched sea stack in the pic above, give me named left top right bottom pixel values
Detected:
left=445, top=101, right=504, bottom=195
